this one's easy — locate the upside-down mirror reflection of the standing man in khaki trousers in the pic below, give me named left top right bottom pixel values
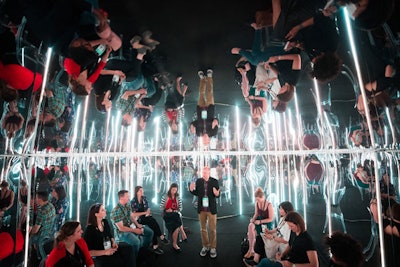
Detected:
left=190, top=69, right=219, bottom=146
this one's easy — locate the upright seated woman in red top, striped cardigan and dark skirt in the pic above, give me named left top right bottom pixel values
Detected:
left=160, top=183, right=187, bottom=253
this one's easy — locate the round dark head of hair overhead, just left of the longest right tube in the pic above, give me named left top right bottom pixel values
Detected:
left=310, top=52, right=343, bottom=83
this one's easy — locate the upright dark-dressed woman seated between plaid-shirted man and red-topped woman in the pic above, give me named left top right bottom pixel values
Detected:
left=131, top=185, right=169, bottom=254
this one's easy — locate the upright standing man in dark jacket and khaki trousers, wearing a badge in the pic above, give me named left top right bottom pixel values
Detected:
left=190, top=166, right=219, bottom=258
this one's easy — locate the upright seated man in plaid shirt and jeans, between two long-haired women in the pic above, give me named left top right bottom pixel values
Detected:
left=110, top=190, right=154, bottom=258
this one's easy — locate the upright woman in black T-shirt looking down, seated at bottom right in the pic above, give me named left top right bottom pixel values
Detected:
left=257, top=211, right=319, bottom=267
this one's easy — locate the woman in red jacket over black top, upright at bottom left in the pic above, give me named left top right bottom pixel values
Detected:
left=45, top=221, right=94, bottom=267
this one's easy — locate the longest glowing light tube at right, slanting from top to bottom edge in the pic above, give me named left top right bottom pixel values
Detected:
left=343, top=8, right=386, bottom=267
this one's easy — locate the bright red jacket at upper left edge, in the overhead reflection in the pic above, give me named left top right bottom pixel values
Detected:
left=0, top=62, right=43, bottom=92
